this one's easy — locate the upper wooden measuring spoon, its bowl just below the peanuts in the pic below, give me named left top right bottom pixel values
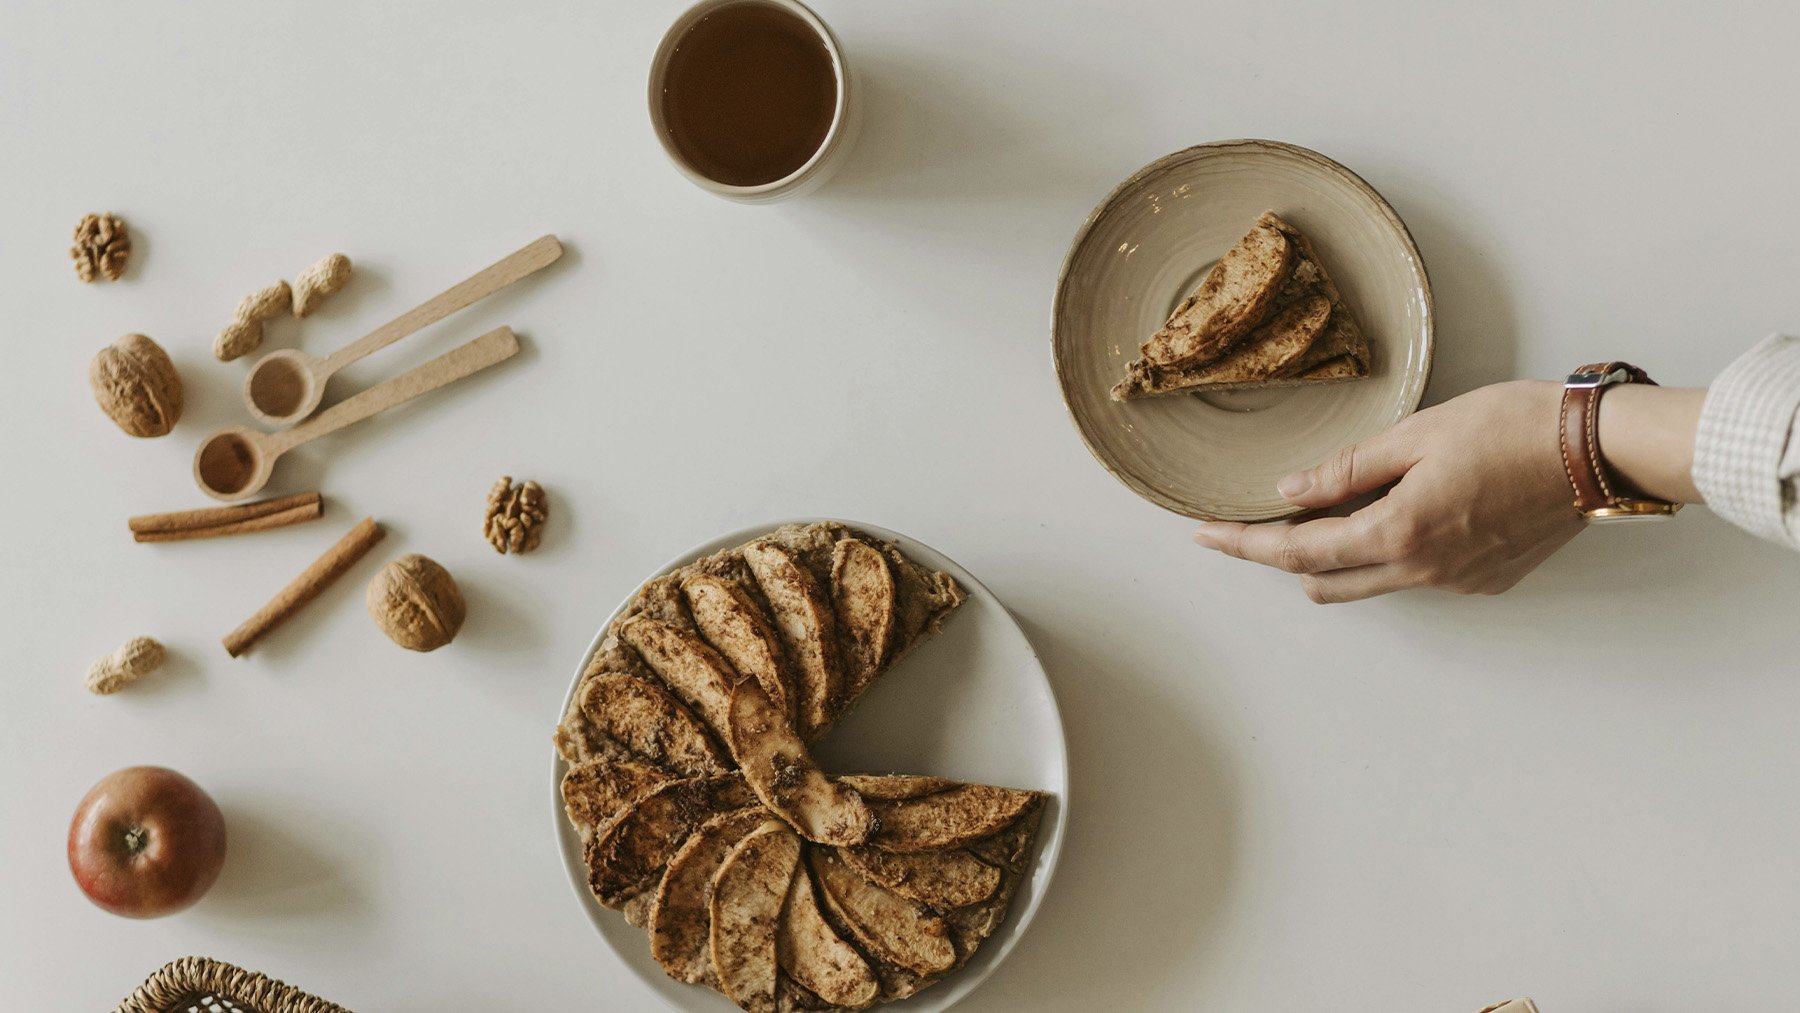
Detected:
left=243, top=236, right=562, bottom=428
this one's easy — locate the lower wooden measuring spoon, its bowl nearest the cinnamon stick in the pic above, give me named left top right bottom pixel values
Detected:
left=194, top=327, right=518, bottom=500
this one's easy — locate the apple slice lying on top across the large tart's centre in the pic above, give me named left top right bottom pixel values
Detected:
left=731, top=678, right=875, bottom=844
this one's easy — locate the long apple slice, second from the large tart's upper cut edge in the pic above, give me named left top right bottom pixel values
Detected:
left=743, top=540, right=844, bottom=741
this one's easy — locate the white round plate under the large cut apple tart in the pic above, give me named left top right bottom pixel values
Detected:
left=551, top=520, right=1069, bottom=1013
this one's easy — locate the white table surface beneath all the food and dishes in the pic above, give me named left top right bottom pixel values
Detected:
left=0, top=0, right=1800, bottom=1013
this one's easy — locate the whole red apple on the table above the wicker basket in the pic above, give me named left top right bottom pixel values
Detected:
left=68, top=766, right=225, bottom=918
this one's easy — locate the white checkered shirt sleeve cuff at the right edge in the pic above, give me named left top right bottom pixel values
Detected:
left=1694, top=335, right=1800, bottom=549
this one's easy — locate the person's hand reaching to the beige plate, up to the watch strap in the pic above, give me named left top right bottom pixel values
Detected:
left=1193, top=380, right=1584, bottom=605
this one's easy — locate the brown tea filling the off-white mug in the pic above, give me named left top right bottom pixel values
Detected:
left=662, top=0, right=837, bottom=187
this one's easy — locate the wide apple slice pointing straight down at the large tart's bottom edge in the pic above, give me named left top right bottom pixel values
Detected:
left=709, top=820, right=801, bottom=1013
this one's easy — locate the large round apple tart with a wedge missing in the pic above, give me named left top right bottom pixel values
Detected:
left=556, top=522, right=1046, bottom=1011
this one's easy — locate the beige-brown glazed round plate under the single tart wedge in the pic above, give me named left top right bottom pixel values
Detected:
left=1051, top=140, right=1431, bottom=520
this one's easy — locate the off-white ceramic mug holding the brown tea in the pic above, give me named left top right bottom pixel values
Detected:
left=650, top=0, right=862, bottom=203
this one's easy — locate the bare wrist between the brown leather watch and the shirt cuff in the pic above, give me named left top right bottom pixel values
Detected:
left=1598, top=383, right=1706, bottom=504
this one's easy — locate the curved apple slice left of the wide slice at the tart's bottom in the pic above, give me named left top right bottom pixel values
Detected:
left=648, top=806, right=769, bottom=984
